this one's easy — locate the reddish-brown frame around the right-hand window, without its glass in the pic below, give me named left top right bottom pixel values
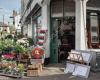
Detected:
left=87, top=10, right=100, bottom=49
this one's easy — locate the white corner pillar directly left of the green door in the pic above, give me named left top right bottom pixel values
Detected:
left=42, top=4, right=50, bottom=58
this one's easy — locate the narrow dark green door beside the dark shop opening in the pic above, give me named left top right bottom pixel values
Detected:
left=50, top=19, right=58, bottom=63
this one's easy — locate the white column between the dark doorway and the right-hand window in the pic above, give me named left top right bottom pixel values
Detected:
left=75, top=0, right=87, bottom=50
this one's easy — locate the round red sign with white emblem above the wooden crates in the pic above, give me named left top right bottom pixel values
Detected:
left=32, top=47, right=44, bottom=59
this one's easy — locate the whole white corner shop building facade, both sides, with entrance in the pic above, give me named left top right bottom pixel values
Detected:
left=21, top=0, right=100, bottom=63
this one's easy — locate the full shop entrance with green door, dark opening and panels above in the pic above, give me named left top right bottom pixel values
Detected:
left=50, top=0, right=75, bottom=63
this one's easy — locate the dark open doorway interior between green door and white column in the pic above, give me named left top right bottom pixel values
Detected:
left=58, top=16, right=75, bottom=62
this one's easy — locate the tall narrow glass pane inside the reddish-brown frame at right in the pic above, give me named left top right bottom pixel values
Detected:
left=90, top=14, right=99, bottom=43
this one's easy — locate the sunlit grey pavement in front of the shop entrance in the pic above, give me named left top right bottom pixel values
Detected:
left=0, top=64, right=100, bottom=80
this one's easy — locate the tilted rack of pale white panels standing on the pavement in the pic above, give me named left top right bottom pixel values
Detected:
left=65, top=50, right=92, bottom=78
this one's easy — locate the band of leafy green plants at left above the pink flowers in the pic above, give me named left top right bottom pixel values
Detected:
left=0, top=39, right=28, bottom=53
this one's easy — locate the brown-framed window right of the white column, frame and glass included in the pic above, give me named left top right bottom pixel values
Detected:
left=87, top=11, right=100, bottom=48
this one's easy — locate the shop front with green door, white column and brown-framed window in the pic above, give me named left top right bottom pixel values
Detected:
left=50, top=0, right=100, bottom=63
